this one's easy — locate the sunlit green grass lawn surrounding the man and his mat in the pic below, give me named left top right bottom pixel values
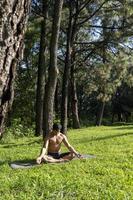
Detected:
left=0, top=125, right=133, bottom=200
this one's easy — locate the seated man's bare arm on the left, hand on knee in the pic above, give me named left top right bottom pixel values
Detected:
left=36, top=138, right=49, bottom=164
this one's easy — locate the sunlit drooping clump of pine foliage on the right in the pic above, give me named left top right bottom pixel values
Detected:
left=85, top=54, right=129, bottom=102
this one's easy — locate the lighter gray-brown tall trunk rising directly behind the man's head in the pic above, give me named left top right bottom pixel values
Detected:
left=43, top=0, right=63, bottom=137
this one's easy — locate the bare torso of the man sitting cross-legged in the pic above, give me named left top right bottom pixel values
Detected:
left=48, top=132, right=63, bottom=153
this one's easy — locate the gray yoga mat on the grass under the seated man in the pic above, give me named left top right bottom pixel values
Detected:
left=9, top=154, right=96, bottom=169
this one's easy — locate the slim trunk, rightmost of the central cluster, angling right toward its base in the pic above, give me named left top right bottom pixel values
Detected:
left=71, top=63, right=80, bottom=128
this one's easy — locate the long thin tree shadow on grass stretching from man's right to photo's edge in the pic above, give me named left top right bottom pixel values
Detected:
left=76, top=133, right=133, bottom=143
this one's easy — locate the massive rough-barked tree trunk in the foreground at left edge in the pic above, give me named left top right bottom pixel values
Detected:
left=0, top=0, right=30, bottom=138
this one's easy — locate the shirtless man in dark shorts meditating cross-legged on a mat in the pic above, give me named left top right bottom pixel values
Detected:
left=36, top=124, right=81, bottom=164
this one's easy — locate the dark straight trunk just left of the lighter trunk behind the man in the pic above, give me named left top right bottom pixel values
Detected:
left=35, top=0, right=48, bottom=136
